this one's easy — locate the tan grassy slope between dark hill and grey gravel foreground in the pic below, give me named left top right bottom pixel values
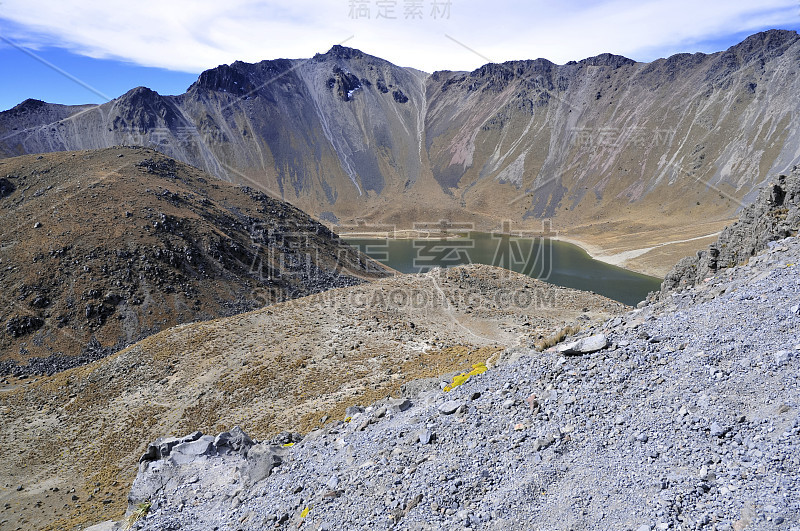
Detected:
left=0, top=266, right=626, bottom=530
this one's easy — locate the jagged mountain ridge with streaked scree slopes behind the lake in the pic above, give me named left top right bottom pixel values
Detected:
left=0, top=30, right=800, bottom=274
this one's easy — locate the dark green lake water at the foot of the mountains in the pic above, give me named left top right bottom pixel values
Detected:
left=345, top=233, right=661, bottom=306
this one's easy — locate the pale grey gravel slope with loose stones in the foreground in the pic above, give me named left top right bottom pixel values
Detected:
left=94, top=237, right=800, bottom=531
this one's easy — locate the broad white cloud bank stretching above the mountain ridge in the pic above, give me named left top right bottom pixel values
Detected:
left=0, top=0, right=800, bottom=72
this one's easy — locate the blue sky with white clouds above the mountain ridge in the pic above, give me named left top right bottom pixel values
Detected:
left=0, top=0, right=800, bottom=110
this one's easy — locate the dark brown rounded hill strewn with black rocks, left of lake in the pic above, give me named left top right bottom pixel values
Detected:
left=0, top=148, right=388, bottom=375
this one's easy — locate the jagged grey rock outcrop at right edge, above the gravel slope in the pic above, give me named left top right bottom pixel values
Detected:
left=652, top=166, right=800, bottom=298
